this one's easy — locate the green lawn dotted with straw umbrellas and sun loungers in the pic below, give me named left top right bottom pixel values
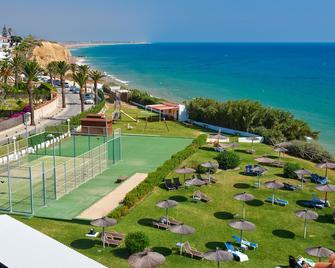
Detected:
left=18, top=141, right=335, bottom=268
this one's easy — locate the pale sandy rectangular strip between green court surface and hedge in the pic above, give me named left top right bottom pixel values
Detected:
left=77, top=173, right=148, bottom=220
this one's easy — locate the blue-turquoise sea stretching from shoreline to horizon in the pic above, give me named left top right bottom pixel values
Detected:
left=72, top=43, right=335, bottom=153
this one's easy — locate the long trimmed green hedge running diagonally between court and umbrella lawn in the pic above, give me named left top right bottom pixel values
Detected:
left=109, top=134, right=207, bottom=218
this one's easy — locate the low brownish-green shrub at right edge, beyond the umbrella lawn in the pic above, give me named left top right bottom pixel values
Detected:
left=287, top=140, right=334, bottom=163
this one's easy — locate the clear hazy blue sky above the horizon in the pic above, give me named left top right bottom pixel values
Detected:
left=0, top=0, right=335, bottom=42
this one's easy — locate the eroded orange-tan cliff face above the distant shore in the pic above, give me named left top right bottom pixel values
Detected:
left=32, top=41, right=71, bottom=67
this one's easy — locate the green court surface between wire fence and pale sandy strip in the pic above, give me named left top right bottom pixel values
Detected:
left=35, top=136, right=192, bottom=219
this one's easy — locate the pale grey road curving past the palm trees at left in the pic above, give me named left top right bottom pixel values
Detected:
left=0, top=88, right=92, bottom=144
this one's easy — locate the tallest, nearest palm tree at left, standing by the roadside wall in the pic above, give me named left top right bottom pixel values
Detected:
left=22, top=60, right=42, bottom=126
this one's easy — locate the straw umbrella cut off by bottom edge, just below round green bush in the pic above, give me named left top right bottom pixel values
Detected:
left=128, top=250, right=165, bottom=268
